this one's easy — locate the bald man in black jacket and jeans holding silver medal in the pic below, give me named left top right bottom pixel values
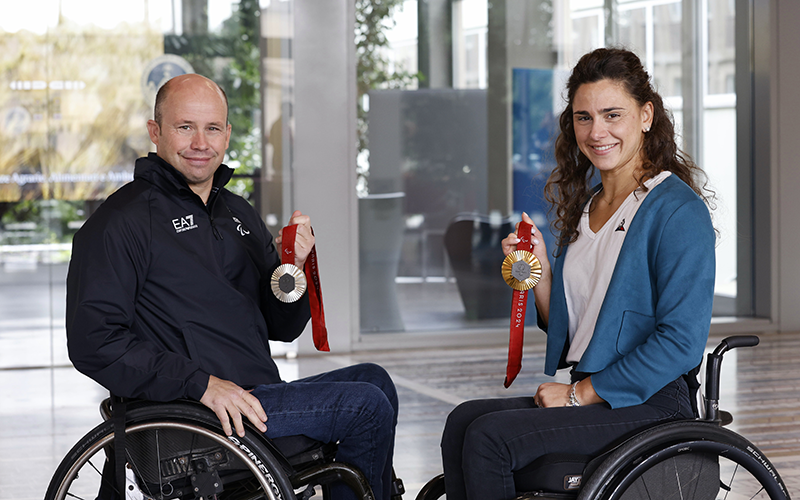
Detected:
left=67, top=74, right=397, bottom=499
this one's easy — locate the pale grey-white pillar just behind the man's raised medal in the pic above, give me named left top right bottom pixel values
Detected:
left=293, top=0, right=358, bottom=353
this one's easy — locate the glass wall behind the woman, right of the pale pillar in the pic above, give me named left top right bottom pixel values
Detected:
left=357, top=0, right=749, bottom=334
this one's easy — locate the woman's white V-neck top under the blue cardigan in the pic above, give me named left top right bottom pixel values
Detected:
left=564, top=172, right=672, bottom=363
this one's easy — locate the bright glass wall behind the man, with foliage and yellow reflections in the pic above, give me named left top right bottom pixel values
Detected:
left=0, top=0, right=263, bottom=369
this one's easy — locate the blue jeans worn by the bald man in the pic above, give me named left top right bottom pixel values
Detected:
left=253, top=363, right=398, bottom=500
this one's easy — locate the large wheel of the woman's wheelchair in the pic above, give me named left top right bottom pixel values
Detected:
left=578, top=422, right=789, bottom=500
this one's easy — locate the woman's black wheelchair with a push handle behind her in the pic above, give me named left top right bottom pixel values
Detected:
left=417, top=335, right=789, bottom=500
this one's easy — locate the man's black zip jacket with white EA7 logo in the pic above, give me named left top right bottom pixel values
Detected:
left=66, top=153, right=310, bottom=401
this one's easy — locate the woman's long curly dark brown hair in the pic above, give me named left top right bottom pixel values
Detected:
left=544, top=48, right=713, bottom=255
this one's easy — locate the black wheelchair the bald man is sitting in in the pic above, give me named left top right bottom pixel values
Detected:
left=45, top=396, right=404, bottom=500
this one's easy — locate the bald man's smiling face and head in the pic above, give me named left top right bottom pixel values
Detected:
left=147, top=75, right=231, bottom=200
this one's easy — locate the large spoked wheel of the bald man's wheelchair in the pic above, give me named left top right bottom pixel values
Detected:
left=45, top=404, right=295, bottom=500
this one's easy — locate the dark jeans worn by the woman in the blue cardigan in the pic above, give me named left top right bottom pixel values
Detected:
left=442, top=378, right=693, bottom=500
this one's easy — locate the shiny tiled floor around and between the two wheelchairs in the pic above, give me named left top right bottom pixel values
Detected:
left=0, top=334, right=800, bottom=500
